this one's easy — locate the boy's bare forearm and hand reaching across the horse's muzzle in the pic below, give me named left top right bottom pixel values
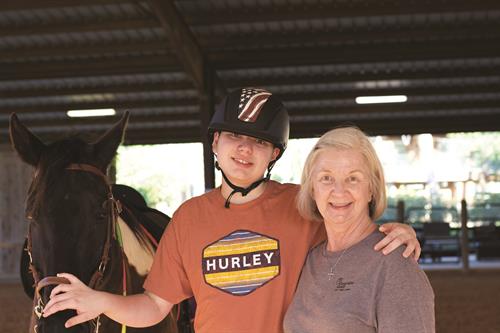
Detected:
left=43, top=273, right=173, bottom=327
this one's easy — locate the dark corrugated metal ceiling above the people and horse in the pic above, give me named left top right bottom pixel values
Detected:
left=0, top=0, right=500, bottom=143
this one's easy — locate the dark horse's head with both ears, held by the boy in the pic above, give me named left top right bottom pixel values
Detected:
left=9, top=113, right=129, bottom=333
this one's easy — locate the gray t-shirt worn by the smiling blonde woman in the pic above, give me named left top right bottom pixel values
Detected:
left=284, top=231, right=435, bottom=333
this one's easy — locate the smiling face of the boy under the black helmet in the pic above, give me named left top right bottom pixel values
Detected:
left=212, top=132, right=279, bottom=187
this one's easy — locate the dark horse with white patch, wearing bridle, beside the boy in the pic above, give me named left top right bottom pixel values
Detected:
left=9, top=113, right=188, bottom=333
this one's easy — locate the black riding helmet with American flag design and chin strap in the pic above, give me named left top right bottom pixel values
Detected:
left=208, top=88, right=290, bottom=207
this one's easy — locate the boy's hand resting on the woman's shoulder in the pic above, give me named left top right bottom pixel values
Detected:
left=374, top=223, right=422, bottom=261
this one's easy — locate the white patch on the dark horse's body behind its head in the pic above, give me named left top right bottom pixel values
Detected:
left=118, top=217, right=154, bottom=276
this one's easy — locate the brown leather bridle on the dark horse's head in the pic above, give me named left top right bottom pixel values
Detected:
left=26, top=163, right=121, bottom=333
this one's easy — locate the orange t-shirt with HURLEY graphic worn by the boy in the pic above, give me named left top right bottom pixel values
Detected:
left=144, top=181, right=325, bottom=333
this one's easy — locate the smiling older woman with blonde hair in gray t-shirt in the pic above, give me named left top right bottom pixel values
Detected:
left=284, top=127, right=435, bottom=333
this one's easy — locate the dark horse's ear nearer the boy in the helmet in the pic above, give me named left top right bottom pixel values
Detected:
left=94, top=111, right=130, bottom=170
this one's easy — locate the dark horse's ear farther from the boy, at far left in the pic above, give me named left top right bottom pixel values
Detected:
left=9, top=113, right=45, bottom=166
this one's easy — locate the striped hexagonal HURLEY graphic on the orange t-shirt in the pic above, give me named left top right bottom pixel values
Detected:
left=202, top=230, right=280, bottom=296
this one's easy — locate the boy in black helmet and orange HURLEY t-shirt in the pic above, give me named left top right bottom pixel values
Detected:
left=44, top=88, right=419, bottom=333
